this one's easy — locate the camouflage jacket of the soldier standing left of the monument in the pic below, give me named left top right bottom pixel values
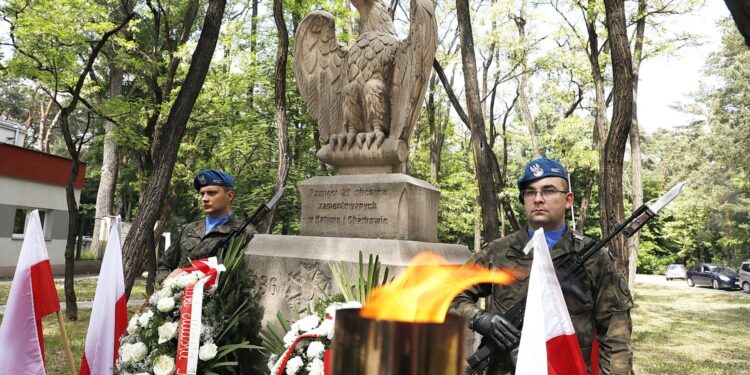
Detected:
left=156, top=215, right=257, bottom=282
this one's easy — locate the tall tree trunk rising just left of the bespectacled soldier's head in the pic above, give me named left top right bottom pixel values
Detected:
left=456, top=0, right=500, bottom=242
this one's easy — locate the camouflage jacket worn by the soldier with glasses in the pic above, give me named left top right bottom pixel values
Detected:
left=451, top=228, right=633, bottom=375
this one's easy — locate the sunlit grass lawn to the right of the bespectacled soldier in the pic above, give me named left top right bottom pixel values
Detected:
left=632, top=284, right=750, bottom=375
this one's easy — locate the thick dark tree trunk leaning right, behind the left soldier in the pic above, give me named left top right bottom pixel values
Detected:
left=123, top=0, right=226, bottom=296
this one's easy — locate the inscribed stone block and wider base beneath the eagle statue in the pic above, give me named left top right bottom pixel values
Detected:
left=246, top=173, right=470, bottom=324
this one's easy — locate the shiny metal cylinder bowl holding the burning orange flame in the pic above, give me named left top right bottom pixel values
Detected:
left=331, top=309, right=466, bottom=375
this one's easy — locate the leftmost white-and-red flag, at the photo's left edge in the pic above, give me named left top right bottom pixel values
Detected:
left=0, top=210, right=60, bottom=375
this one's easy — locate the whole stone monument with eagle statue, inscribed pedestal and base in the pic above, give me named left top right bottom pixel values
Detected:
left=247, top=0, right=469, bottom=322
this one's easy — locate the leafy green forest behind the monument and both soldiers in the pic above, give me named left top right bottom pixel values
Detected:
left=0, top=0, right=750, bottom=319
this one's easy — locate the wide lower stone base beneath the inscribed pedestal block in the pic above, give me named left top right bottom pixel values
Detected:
left=245, top=234, right=471, bottom=326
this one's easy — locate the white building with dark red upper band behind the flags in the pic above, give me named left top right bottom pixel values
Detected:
left=0, top=142, right=86, bottom=277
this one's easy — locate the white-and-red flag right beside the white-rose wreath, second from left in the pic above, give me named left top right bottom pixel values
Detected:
left=79, top=216, right=128, bottom=375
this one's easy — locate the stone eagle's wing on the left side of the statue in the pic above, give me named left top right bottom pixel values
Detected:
left=294, top=11, right=347, bottom=142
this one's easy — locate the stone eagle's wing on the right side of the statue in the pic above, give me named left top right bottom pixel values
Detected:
left=389, top=0, right=437, bottom=141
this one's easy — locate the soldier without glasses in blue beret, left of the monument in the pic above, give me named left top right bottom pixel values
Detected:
left=156, top=169, right=256, bottom=282
